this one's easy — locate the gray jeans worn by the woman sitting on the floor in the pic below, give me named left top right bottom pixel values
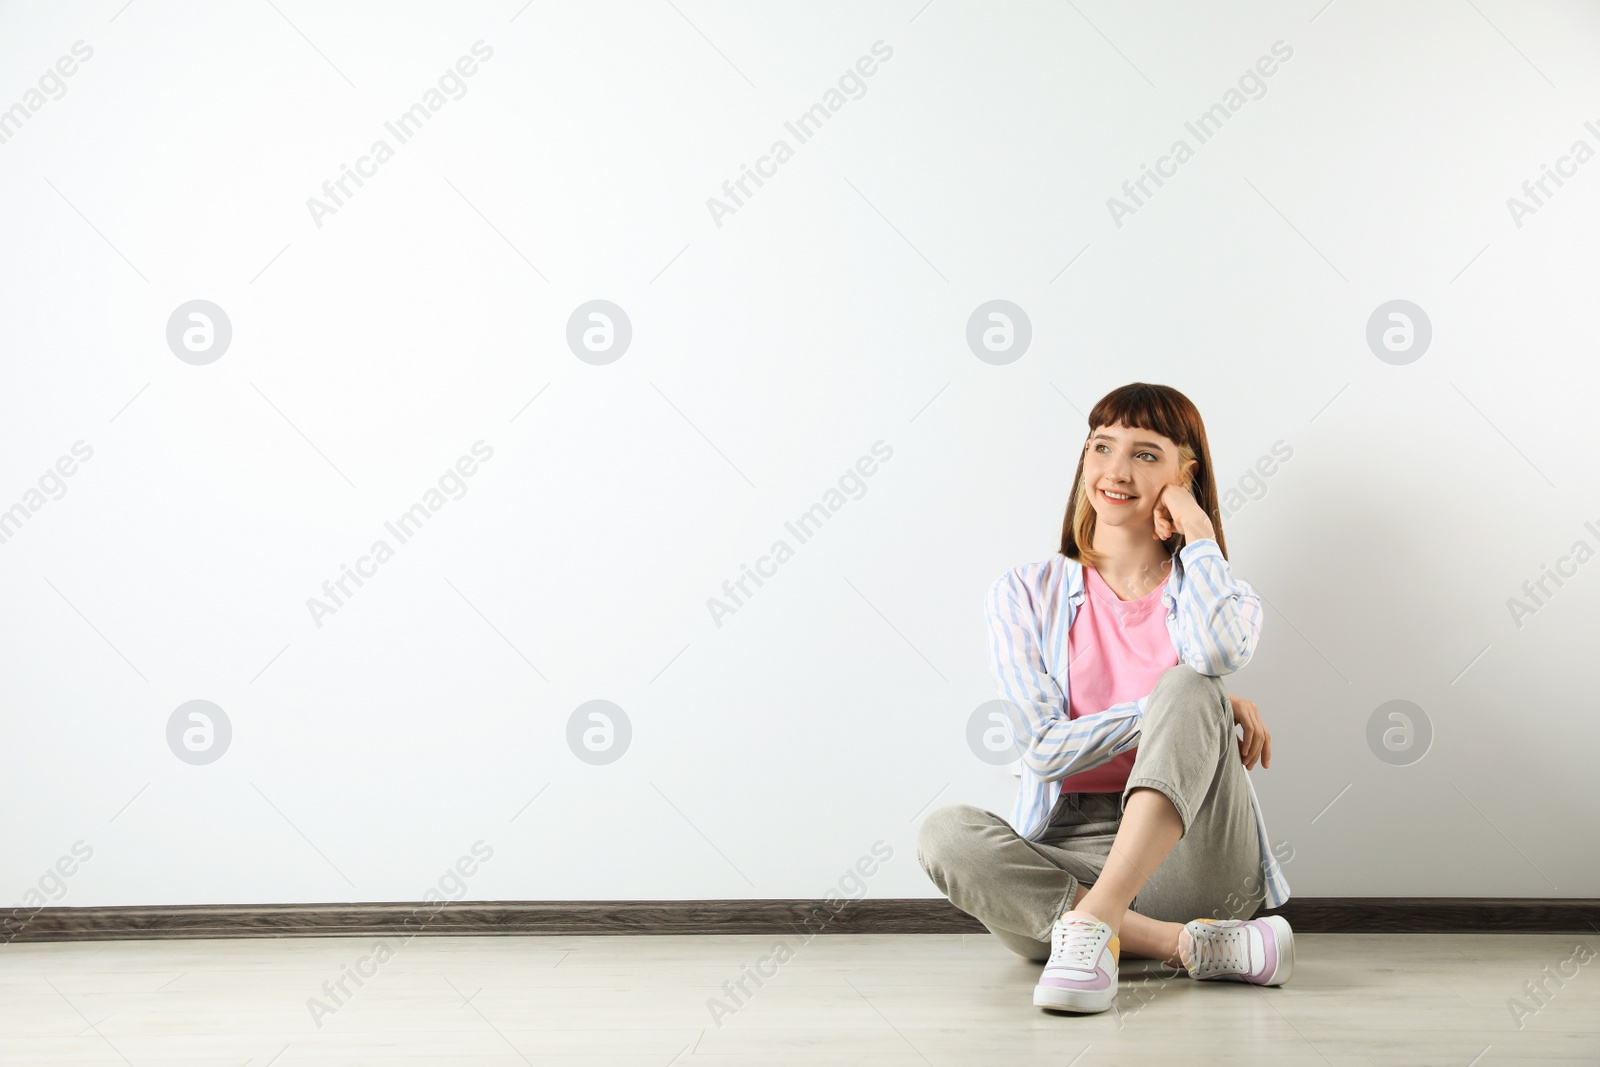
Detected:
left=917, top=664, right=1266, bottom=960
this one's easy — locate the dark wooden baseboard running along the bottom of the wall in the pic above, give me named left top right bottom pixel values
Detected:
left=9, top=896, right=1600, bottom=945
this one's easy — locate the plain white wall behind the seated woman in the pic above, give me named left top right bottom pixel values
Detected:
left=0, top=0, right=1600, bottom=905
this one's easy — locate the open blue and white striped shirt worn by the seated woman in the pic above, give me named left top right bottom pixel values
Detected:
left=987, top=537, right=1290, bottom=909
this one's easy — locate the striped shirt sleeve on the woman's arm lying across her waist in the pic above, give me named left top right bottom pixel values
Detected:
left=986, top=571, right=1149, bottom=782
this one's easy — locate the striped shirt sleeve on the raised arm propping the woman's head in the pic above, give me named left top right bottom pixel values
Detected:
left=1178, top=537, right=1261, bottom=675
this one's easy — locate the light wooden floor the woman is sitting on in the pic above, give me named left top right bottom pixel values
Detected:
left=0, top=934, right=1600, bottom=1067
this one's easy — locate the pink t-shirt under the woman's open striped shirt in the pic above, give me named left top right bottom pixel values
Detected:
left=1061, top=566, right=1178, bottom=793
